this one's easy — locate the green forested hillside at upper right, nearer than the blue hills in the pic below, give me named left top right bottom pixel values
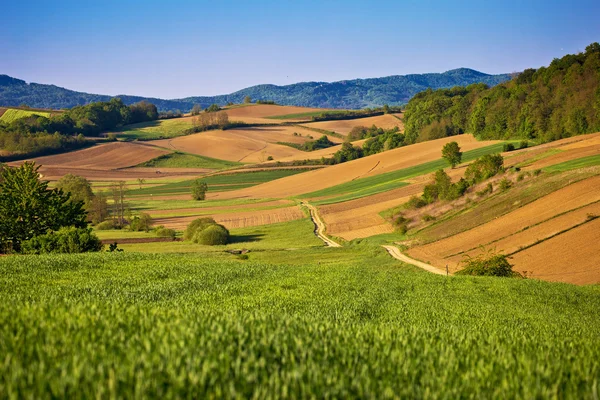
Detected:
left=404, top=43, right=600, bottom=142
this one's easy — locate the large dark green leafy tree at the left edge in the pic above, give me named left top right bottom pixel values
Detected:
left=0, top=162, right=87, bottom=251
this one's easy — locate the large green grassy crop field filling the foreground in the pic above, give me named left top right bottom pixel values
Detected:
left=0, top=245, right=600, bottom=399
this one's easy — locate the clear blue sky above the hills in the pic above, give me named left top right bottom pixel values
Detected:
left=0, top=0, right=600, bottom=98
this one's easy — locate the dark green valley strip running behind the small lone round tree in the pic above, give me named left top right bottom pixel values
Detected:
left=128, top=169, right=314, bottom=196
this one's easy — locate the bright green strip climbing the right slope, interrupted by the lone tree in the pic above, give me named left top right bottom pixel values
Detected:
left=300, top=143, right=503, bottom=204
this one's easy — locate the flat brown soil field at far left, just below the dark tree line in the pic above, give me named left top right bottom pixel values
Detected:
left=12, top=142, right=169, bottom=171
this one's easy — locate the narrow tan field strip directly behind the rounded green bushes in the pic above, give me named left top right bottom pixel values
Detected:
left=154, top=206, right=306, bottom=230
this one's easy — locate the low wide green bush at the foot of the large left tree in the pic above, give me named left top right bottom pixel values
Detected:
left=21, top=227, right=103, bottom=254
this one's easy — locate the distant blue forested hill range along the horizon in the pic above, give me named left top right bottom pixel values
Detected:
left=0, top=68, right=511, bottom=112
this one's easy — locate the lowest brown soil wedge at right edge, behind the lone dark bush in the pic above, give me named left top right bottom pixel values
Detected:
left=511, top=219, right=600, bottom=285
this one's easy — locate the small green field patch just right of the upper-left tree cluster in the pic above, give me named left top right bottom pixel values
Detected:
left=116, top=118, right=192, bottom=140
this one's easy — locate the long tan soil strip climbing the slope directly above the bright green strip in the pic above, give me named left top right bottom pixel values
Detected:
left=211, top=135, right=497, bottom=199
